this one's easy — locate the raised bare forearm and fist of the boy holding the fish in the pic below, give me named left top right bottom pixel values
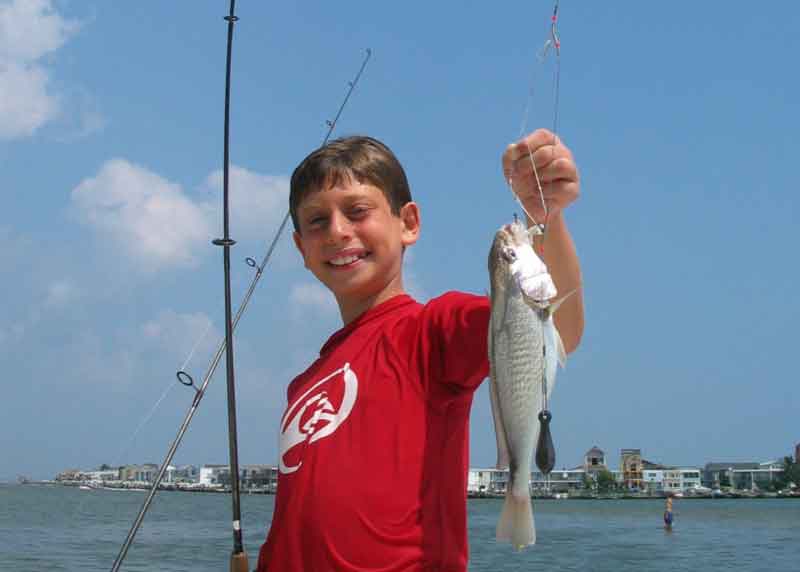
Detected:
left=503, top=129, right=584, bottom=353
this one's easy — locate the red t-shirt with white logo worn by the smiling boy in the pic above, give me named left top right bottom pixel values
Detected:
left=258, top=292, right=489, bottom=572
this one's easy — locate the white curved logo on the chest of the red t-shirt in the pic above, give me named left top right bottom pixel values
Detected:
left=278, top=363, right=358, bottom=474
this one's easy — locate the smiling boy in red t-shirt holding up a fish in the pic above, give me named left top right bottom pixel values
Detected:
left=258, top=130, right=583, bottom=572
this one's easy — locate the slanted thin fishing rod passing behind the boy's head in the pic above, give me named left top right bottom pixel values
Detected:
left=104, top=23, right=372, bottom=572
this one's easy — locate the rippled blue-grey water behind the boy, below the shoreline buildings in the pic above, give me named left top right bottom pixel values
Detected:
left=0, top=486, right=800, bottom=572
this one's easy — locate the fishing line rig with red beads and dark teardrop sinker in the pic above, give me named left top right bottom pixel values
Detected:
left=508, top=0, right=561, bottom=478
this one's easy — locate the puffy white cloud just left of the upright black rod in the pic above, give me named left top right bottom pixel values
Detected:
left=72, top=159, right=211, bottom=272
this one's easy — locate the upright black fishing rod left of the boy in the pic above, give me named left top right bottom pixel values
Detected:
left=212, top=0, right=248, bottom=572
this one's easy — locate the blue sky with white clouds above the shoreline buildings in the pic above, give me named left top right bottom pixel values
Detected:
left=0, top=0, right=800, bottom=479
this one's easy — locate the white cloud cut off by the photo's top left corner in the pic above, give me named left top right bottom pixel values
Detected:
left=0, top=0, right=78, bottom=139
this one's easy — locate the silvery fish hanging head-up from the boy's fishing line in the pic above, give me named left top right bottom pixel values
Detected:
left=488, top=220, right=570, bottom=550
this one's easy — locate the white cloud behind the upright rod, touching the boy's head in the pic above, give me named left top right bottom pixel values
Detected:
left=204, top=166, right=289, bottom=240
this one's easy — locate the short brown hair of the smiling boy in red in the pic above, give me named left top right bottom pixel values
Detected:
left=289, top=135, right=411, bottom=232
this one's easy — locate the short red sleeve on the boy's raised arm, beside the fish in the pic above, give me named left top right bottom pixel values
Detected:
left=420, top=292, right=489, bottom=390
